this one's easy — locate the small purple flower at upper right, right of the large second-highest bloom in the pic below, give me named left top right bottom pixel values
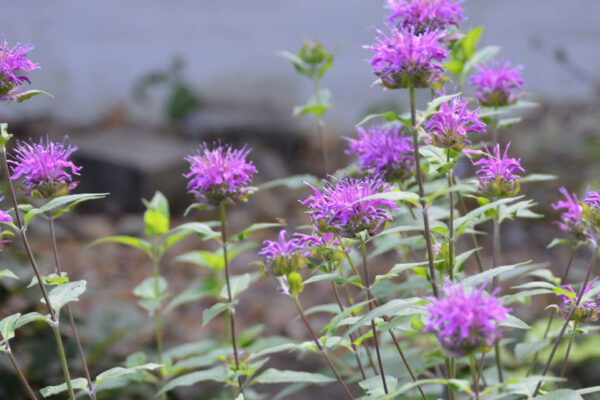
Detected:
left=469, top=60, right=525, bottom=107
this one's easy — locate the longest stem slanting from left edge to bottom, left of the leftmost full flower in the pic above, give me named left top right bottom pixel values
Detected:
left=2, top=146, right=75, bottom=400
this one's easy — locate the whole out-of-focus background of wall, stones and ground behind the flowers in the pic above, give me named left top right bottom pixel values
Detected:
left=0, top=0, right=600, bottom=399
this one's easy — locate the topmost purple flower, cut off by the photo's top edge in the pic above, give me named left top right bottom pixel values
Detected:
left=386, top=0, right=465, bottom=32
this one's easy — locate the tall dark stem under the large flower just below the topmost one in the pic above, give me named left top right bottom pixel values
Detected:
left=409, top=85, right=439, bottom=297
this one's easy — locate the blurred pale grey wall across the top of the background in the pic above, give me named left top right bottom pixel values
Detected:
left=0, top=0, right=600, bottom=129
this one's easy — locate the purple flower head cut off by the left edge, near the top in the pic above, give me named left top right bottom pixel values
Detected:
left=0, top=40, right=39, bottom=101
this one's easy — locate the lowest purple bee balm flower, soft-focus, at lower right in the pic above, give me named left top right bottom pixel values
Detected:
left=425, top=283, right=510, bottom=357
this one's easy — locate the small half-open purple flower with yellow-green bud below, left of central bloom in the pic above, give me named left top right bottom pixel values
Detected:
left=258, top=230, right=309, bottom=296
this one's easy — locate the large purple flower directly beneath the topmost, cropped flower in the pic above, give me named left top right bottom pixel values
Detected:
left=363, top=28, right=448, bottom=89
